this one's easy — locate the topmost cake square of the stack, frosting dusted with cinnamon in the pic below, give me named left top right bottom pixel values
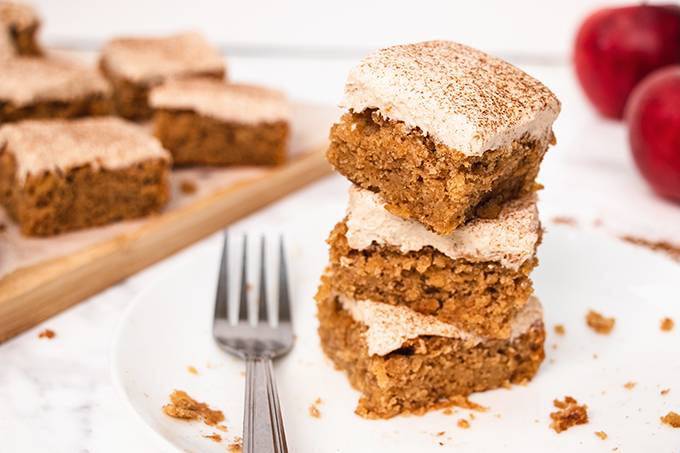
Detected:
left=327, top=41, right=560, bottom=234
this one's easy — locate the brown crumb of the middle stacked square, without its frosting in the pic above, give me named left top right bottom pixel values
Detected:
left=328, top=221, right=538, bottom=338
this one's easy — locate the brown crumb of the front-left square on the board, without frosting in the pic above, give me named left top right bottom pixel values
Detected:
left=0, top=149, right=170, bottom=236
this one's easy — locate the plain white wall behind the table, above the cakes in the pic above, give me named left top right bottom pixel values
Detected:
left=33, top=0, right=644, bottom=58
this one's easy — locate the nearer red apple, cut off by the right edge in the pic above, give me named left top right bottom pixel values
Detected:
left=626, top=65, right=680, bottom=201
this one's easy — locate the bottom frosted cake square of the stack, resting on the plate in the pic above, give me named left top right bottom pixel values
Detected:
left=316, top=278, right=545, bottom=418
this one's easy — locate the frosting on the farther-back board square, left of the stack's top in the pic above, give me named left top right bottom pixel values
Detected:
left=102, top=33, right=225, bottom=82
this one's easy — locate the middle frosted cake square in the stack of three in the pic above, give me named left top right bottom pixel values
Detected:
left=328, top=186, right=541, bottom=339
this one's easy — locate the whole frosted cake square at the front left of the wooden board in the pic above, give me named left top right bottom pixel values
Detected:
left=0, top=117, right=171, bottom=236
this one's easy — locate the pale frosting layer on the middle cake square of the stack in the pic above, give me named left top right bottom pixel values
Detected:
left=346, top=186, right=541, bottom=269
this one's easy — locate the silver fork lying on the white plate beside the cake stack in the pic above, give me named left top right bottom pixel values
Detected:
left=213, top=231, right=294, bottom=453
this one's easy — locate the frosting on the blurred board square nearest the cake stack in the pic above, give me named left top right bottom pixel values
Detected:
left=149, top=79, right=290, bottom=125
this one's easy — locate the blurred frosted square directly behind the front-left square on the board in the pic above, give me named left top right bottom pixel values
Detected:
left=0, top=56, right=112, bottom=123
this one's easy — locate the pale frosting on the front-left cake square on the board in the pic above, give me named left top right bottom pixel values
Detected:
left=0, top=117, right=170, bottom=182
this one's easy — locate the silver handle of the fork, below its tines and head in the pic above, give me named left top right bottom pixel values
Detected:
left=243, top=357, right=288, bottom=453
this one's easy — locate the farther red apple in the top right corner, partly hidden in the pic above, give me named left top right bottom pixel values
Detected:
left=574, top=5, right=680, bottom=118
